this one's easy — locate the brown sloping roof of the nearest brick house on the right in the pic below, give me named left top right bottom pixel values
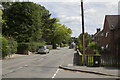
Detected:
left=105, top=15, right=120, bottom=30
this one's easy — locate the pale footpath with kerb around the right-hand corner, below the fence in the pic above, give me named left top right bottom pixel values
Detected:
left=59, top=49, right=120, bottom=78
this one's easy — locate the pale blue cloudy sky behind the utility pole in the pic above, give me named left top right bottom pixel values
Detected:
left=29, top=0, right=119, bottom=37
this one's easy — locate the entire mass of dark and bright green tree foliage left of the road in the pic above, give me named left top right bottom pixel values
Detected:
left=2, top=2, right=72, bottom=48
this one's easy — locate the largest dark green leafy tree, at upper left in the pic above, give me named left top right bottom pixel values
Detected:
left=3, top=2, right=49, bottom=43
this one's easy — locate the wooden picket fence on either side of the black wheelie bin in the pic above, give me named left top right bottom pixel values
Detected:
left=85, top=55, right=119, bottom=67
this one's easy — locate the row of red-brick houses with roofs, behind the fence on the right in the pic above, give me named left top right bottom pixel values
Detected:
left=93, top=15, right=120, bottom=56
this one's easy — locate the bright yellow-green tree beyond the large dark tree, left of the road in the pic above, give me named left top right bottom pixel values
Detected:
left=52, top=23, right=72, bottom=47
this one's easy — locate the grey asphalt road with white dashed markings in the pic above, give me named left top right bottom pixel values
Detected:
left=2, top=47, right=118, bottom=78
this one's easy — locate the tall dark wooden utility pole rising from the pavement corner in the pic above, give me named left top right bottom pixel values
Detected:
left=81, top=0, right=85, bottom=66
